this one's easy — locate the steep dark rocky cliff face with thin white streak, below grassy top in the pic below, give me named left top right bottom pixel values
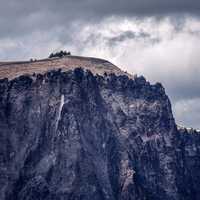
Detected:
left=0, top=66, right=200, bottom=200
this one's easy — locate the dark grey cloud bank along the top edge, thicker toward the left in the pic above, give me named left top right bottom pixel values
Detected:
left=0, top=0, right=200, bottom=37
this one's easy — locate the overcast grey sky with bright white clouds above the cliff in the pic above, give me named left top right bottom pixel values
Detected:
left=0, top=0, right=200, bottom=128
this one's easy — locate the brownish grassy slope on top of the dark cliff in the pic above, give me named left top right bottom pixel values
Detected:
left=0, top=55, right=131, bottom=79
